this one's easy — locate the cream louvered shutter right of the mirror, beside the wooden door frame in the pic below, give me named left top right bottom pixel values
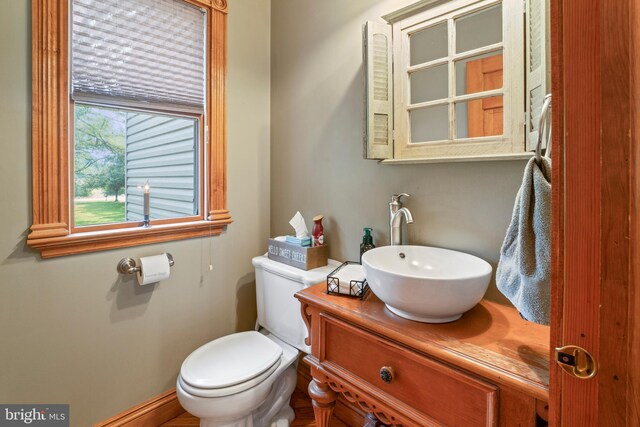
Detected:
left=525, top=0, right=551, bottom=150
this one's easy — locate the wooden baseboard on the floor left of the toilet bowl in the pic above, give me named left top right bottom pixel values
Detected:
left=93, top=388, right=185, bottom=427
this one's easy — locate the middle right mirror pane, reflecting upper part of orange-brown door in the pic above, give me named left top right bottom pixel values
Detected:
left=455, top=51, right=502, bottom=95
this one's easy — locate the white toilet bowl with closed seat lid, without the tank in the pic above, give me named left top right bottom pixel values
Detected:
left=176, top=331, right=298, bottom=427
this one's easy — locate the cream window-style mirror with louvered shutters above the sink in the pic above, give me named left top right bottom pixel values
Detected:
left=365, top=0, right=546, bottom=161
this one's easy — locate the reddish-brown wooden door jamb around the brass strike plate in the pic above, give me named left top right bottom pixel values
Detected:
left=550, top=0, right=640, bottom=427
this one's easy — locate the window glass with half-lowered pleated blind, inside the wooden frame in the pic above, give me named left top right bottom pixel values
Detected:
left=69, top=0, right=207, bottom=230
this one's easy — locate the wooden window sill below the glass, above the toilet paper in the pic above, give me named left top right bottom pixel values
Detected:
left=27, top=216, right=233, bottom=258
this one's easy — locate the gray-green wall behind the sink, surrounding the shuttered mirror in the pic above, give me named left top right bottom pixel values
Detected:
left=271, top=0, right=525, bottom=308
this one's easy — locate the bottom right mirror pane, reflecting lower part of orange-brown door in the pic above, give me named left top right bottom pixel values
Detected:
left=455, top=96, right=504, bottom=139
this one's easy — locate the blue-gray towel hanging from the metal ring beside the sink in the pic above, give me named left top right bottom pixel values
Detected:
left=496, top=157, right=551, bottom=325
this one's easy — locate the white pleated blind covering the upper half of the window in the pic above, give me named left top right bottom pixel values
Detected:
left=70, top=0, right=206, bottom=112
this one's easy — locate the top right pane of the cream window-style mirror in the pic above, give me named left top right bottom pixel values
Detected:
left=456, top=4, right=502, bottom=53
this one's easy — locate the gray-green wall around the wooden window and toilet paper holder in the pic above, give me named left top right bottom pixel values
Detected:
left=0, top=0, right=270, bottom=426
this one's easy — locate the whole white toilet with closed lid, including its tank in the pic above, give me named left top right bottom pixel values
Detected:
left=176, top=256, right=340, bottom=427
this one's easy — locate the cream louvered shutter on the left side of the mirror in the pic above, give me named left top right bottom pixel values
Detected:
left=363, top=21, right=393, bottom=159
